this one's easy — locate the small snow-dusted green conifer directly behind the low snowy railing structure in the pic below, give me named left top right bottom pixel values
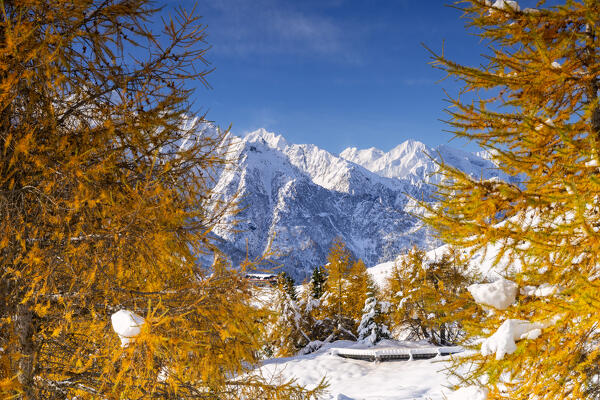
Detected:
left=358, top=282, right=390, bottom=345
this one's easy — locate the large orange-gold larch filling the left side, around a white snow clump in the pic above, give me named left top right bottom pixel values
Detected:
left=0, top=0, right=324, bottom=400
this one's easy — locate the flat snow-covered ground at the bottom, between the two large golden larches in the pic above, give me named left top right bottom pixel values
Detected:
left=255, top=341, right=462, bottom=400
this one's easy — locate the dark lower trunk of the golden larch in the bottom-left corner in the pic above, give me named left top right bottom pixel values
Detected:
left=15, top=304, right=35, bottom=400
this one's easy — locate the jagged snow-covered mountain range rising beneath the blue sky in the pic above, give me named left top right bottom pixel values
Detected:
left=214, top=130, right=506, bottom=280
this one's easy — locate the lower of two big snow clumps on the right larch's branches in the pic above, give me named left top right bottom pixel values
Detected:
left=481, top=319, right=543, bottom=360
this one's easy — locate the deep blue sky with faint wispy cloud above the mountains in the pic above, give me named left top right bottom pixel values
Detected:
left=172, top=0, right=506, bottom=153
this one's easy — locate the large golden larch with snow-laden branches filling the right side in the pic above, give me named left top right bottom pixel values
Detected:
left=427, top=0, right=600, bottom=399
